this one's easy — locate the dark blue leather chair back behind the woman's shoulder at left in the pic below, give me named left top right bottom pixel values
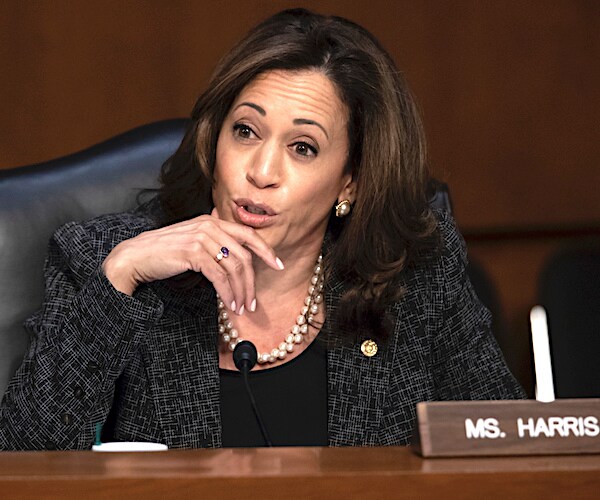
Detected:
left=0, top=119, right=187, bottom=398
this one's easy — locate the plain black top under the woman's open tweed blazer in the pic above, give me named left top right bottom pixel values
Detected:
left=219, top=340, right=329, bottom=447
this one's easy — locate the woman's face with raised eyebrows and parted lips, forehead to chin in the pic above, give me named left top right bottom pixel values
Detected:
left=213, top=71, right=355, bottom=262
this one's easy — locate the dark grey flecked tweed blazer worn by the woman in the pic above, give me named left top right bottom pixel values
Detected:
left=0, top=203, right=524, bottom=449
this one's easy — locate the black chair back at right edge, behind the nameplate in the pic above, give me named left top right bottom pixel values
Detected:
left=539, top=241, right=600, bottom=398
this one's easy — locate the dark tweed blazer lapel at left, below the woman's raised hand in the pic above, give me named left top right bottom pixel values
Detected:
left=146, top=287, right=221, bottom=448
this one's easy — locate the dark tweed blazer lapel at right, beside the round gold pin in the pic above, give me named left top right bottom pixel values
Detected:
left=325, top=283, right=393, bottom=446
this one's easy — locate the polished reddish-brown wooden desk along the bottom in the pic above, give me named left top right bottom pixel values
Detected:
left=0, top=448, right=600, bottom=500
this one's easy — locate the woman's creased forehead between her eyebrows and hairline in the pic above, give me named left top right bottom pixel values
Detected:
left=232, top=70, right=348, bottom=135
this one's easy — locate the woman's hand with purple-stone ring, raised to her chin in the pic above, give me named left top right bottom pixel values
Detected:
left=102, top=208, right=283, bottom=314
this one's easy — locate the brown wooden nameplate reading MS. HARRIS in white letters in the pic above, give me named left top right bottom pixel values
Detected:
left=413, top=398, right=600, bottom=457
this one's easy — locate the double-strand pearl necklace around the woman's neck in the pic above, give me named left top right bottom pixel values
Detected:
left=217, top=255, right=324, bottom=364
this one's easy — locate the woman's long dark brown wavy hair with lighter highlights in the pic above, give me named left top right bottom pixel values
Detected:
left=159, top=9, right=438, bottom=338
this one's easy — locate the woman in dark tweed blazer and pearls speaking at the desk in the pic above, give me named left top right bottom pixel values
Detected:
left=0, top=10, right=523, bottom=449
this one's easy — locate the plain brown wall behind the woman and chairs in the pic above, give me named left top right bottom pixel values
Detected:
left=0, top=0, right=600, bottom=392
